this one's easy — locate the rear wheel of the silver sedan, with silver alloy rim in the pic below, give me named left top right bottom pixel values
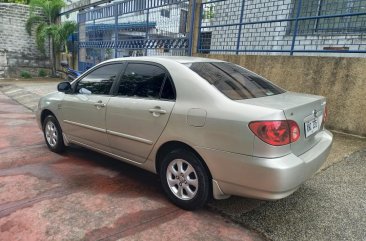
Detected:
left=159, top=149, right=211, bottom=210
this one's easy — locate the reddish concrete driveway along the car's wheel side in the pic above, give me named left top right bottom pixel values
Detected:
left=0, top=91, right=262, bottom=241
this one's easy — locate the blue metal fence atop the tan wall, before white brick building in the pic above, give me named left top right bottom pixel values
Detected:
left=197, top=0, right=366, bottom=56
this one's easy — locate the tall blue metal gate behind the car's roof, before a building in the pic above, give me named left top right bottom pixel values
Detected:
left=78, top=0, right=195, bottom=71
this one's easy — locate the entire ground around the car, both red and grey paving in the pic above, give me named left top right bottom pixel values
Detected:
left=0, top=83, right=366, bottom=241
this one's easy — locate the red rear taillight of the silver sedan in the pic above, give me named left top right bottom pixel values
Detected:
left=249, top=120, right=300, bottom=146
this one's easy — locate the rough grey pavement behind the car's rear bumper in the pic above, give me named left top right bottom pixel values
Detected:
left=212, top=149, right=366, bottom=241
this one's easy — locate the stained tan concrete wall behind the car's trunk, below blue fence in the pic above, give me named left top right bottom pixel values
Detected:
left=196, top=54, right=366, bottom=136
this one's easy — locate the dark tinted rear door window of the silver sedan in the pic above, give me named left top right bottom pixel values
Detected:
left=118, top=64, right=166, bottom=98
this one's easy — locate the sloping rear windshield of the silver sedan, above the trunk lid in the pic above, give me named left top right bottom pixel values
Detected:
left=184, top=62, right=285, bottom=100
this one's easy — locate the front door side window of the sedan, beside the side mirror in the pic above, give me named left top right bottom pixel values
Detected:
left=76, top=63, right=123, bottom=95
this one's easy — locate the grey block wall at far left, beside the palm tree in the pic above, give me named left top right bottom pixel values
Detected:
left=0, top=3, right=50, bottom=78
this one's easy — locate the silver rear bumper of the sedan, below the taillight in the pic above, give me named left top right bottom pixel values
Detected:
left=199, top=130, right=333, bottom=200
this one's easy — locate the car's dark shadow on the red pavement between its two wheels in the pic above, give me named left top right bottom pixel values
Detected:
left=51, top=146, right=166, bottom=202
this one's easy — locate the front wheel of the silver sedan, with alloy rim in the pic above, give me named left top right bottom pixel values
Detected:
left=42, top=115, right=65, bottom=153
